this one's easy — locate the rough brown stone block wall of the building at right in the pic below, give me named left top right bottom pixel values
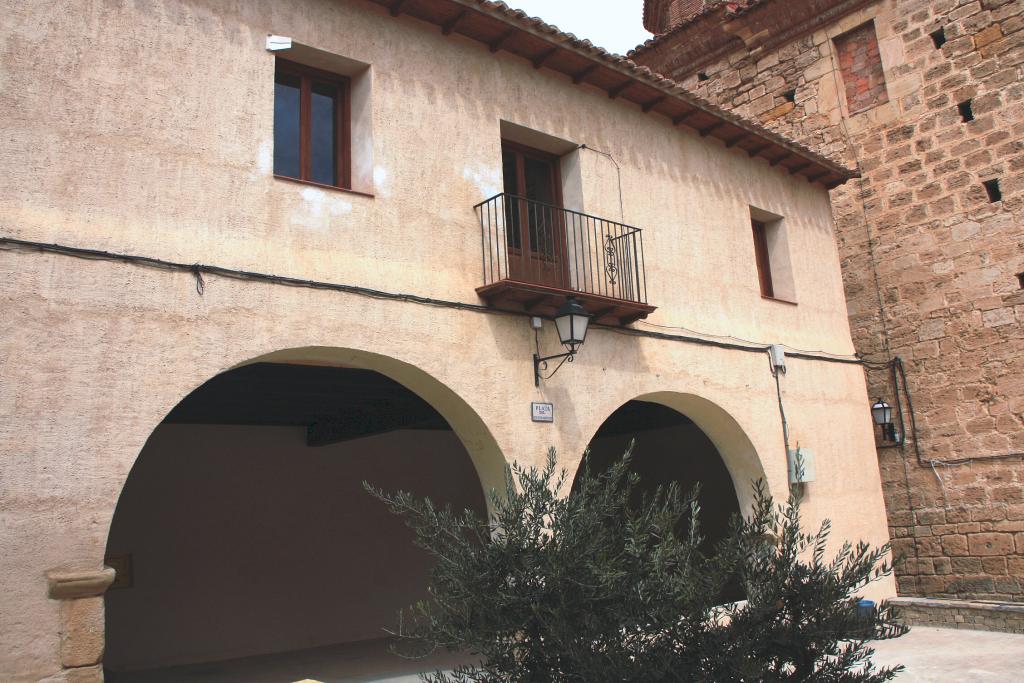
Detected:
left=634, top=0, right=1024, bottom=600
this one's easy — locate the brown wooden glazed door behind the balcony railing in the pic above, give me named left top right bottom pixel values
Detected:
left=502, top=140, right=568, bottom=289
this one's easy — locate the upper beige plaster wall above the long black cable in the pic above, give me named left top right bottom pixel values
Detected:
left=0, top=0, right=851, bottom=353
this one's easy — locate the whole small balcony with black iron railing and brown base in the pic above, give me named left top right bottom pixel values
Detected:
left=474, top=193, right=654, bottom=325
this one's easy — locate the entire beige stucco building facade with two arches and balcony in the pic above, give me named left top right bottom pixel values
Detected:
left=0, top=0, right=894, bottom=681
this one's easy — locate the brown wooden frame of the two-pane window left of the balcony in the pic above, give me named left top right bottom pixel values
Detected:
left=273, top=57, right=352, bottom=190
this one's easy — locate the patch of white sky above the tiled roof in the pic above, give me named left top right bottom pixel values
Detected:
left=505, top=0, right=651, bottom=54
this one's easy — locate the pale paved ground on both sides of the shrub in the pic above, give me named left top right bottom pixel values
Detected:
left=106, top=627, right=1024, bottom=683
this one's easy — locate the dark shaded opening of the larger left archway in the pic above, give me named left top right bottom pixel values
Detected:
left=104, top=362, right=486, bottom=681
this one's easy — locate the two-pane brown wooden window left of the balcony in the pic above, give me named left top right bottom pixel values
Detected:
left=273, top=58, right=351, bottom=188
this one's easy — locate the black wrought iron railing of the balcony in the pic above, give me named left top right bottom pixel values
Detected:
left=474, top=193, right=647, bottom=304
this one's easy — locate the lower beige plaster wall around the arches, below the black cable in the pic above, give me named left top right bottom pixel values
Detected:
left=0, top=252, right=891, bottom=680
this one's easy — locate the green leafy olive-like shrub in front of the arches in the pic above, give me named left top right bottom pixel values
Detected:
left=368, top=452, right=905, bottom=683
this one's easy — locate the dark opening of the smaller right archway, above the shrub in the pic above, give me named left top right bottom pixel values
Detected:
left=577, top=400, right=741, bottom=600
